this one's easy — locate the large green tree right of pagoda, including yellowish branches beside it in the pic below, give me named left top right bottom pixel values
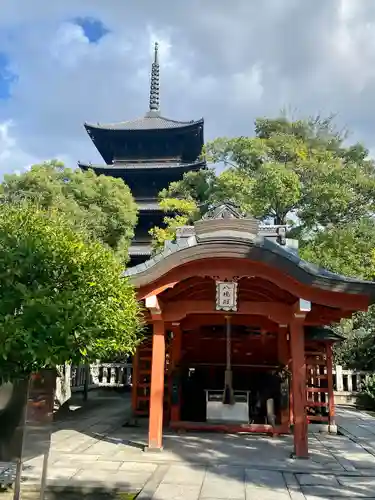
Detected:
left=152, top=116, right=375, bottom=248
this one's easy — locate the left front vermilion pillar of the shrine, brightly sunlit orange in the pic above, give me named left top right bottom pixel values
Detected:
left=148, top=320, right=165, bottom=450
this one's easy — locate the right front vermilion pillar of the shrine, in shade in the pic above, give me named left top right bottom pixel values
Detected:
left=290, top=319, right=309, bottom=458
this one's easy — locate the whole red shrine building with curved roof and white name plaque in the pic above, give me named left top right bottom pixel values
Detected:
left=124, top=203, right=375, bottom=457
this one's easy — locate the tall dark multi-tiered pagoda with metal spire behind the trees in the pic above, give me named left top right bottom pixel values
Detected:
left=78, top=43, right=205, bottom=266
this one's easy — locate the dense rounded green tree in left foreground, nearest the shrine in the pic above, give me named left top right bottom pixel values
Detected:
left=0, top=203, right=142, bottom=379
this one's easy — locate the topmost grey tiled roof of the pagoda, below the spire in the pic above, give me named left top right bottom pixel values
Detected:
left=84, top=111, right=204, bottom=135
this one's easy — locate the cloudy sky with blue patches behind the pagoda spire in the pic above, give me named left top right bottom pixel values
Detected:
left=0, top=0, right=375, bottom=176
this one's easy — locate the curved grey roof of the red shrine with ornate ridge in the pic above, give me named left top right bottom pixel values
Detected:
left=124, top=204, right=375, bottom=304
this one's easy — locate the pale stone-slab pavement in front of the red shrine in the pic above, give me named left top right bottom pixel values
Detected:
left=0, top=397, right=375, bottom=500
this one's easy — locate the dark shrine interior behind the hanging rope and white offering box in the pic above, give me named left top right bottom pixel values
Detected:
left=180, top=325, right=288, bottom=424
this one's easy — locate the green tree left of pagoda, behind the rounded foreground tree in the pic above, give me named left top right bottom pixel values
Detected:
left=0, top=161, right=137, bottom=261
